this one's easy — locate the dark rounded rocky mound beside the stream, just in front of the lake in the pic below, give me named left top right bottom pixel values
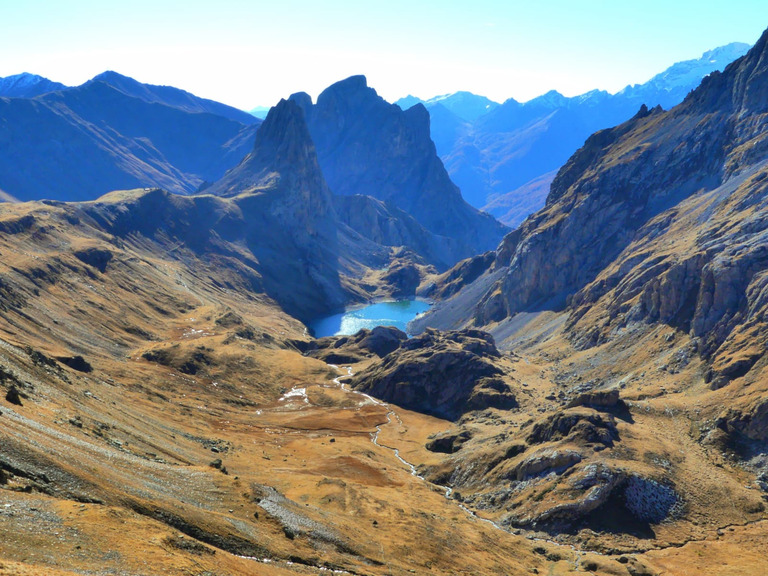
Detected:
left=350, top=330, right=517, bottom=419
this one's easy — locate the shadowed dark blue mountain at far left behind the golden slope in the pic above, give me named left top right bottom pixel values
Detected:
left=0, top=72, right=261, bottom=201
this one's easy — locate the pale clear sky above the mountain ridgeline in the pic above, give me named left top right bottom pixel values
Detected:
left=0, top=0, right=768, bottom=109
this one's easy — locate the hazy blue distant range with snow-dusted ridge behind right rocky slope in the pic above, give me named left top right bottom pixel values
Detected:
left=398, top=43, right=749, bottom=227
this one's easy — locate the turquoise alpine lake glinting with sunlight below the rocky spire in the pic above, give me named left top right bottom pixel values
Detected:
left=309, top=300, right=430, bottom=338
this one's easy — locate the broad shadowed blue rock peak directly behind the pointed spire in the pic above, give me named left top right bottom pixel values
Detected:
left=291, top=76, right=506, bottom=262
